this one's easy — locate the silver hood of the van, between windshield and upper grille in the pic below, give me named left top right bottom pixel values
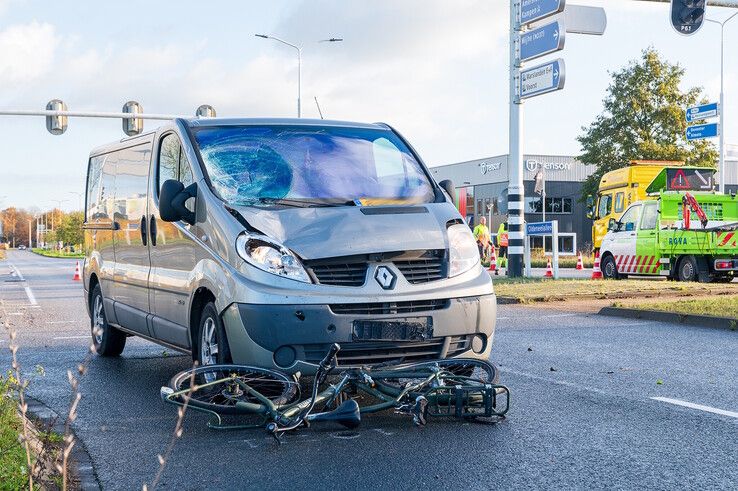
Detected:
left=234, top=203, right=460, bottom=259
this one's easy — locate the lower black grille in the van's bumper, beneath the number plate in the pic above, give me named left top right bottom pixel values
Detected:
left=303, top=336, right=471, bottom=366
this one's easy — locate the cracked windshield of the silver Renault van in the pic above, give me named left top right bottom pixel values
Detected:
left=194, top=125, right=435, bottom=205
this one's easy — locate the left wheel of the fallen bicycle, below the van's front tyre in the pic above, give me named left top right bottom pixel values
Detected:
left=169, top=365, right=300, bottom=414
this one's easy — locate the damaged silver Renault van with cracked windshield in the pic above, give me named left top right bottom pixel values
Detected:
left=83, top=119, right=496, bottom=373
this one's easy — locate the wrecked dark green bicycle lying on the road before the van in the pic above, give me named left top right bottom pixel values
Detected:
left=161, top=344, right=510, bottom=438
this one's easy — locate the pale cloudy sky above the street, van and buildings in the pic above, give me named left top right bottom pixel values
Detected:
left=0, top=0, right=738, bottom=210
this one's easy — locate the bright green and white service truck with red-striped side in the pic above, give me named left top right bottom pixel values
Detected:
left=600, top=191, right=738, bottom=282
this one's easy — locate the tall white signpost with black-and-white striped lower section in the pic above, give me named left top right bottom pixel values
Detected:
left=507, top=0, right=525, bottom=278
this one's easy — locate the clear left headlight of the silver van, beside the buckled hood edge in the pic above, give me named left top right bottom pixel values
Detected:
left=236, top=233, right=311, bottom=283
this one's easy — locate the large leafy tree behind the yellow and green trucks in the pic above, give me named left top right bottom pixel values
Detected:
left=577, top=48, right=718, bottom=200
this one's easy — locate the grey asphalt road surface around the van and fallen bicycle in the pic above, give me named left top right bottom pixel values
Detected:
left=0, top=251, right=738, bottom=489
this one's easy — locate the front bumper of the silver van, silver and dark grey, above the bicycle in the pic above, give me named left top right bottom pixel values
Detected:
left=218, top=294, right=497, bottom=374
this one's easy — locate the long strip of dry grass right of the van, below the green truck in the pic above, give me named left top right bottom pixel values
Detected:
left=492, top=276, right=738, bottom=303
